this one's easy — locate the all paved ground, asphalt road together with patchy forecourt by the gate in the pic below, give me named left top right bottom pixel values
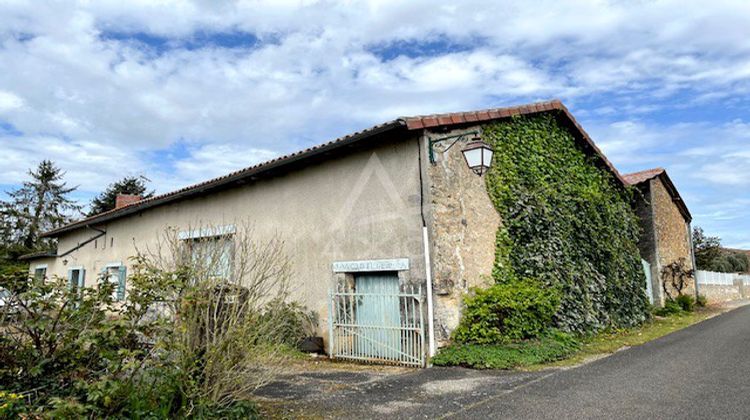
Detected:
left=258, top=306, right=750, bottom=420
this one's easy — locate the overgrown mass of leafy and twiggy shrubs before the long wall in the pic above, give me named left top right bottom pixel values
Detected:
left=0, top=223, right=303, bottom=419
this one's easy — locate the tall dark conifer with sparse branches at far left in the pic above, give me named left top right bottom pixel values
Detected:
left=4, top=160, right=81, bottom=250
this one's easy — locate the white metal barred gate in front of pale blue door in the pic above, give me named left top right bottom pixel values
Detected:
left=328, top=276, right=425, bottom=367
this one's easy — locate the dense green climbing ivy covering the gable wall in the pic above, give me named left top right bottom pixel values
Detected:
left=483, top=113, right=648, bottom=332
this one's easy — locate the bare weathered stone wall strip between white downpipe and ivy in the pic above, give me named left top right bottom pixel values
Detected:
left=427, top=127, right=500, bottom=345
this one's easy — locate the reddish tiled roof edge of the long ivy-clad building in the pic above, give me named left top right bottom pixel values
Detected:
left=42, top=100, right=627, bottom=237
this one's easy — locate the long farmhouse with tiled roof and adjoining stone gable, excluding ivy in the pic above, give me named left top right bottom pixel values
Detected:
left=22, top=100, right=690, bottom=365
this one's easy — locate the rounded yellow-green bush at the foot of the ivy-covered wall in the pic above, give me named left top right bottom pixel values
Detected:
left=454, top=279, right=560, bottom=344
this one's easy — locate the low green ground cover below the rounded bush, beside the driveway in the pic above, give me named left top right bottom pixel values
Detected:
left=432, top=331, right=580, bottom=369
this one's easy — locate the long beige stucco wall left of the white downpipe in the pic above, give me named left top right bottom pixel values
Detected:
left=30, top=137, right=425, bottom=339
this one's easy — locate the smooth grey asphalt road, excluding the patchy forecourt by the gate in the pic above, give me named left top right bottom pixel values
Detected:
left=445, top=306, right=750, bottom=419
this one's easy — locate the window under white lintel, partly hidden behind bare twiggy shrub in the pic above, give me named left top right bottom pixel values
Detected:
left=187, top=235, right=234, bottom=279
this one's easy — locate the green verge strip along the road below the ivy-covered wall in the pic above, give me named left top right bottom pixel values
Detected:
left=432, top=308, right=721, bottom=370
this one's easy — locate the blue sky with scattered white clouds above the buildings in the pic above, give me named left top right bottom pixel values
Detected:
left=0, top=0, right=750, bottom=248
